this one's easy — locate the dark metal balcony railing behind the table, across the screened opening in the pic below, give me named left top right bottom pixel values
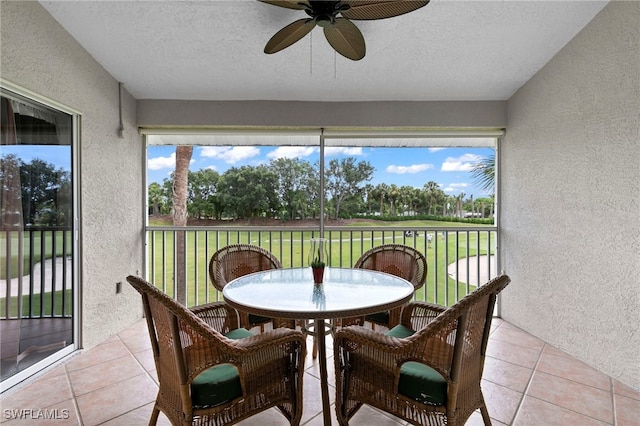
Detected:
left=147, top=225, right=497, bottom=306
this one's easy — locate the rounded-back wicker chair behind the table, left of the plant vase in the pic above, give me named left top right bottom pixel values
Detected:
left=209, top=244, right=286, bottom=331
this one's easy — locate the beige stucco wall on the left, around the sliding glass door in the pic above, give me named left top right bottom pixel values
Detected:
left=0, top=0, right=143, bottom=347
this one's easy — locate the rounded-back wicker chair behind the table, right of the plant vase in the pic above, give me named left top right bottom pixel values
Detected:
left=352, top=244, right=427, bottom=328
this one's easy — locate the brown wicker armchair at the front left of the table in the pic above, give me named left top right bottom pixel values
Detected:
left=127, top=276, right=306, bottom=425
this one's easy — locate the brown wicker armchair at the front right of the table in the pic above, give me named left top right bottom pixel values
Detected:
left=333, top=275, right=510, bottom=425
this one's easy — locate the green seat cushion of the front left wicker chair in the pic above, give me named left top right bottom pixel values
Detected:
left=191, top=328, right=253, bottom=408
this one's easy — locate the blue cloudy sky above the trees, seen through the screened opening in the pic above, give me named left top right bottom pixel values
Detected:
left=147, top=146, right=493, bottom=198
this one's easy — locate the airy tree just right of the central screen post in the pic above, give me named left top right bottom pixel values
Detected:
left=325, top=157, right=375, bottom=219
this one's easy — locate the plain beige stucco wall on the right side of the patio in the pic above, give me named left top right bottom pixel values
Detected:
left=500, top=2, right=640, bottom=389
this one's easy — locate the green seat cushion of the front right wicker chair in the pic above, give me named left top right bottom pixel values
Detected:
left=385, top=325, right=447, bottom=405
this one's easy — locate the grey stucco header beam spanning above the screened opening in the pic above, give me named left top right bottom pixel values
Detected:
left=137, top=99, right=507, bottom=129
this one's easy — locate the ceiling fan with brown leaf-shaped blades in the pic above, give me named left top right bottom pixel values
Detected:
left=259, top=0, right=430, bottom=61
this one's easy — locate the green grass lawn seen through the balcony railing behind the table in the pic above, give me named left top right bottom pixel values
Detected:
left=148, top=221, right=495, bottom=306
